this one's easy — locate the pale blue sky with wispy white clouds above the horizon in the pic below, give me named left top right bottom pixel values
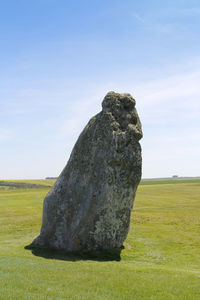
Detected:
left=0, top=0, right=200, bottom=179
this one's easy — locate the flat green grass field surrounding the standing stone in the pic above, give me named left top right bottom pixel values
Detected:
left=0, top=179, right=200, bottom=300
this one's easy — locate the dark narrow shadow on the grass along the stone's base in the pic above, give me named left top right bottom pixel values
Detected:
left=24, top=244, right=122, bottom=261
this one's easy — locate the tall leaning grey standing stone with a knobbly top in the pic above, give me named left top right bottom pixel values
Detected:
left=33, top=92, right=142, bottom=251
